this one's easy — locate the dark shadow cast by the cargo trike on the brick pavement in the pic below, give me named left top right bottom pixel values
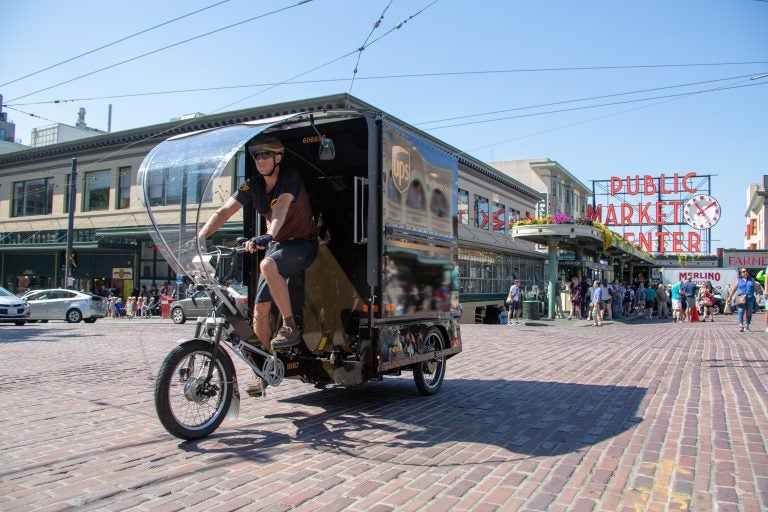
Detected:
left=180, top=379, right=646, bottom=465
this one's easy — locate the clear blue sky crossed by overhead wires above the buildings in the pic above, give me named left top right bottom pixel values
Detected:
left=0, top=0, right=768, bottom=251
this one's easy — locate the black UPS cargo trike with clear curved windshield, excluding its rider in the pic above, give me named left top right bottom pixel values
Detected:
left=139, top=109, right=461, bottom=439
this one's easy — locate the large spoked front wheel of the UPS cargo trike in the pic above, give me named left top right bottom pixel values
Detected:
left=155, top=340, right=235, bottom=440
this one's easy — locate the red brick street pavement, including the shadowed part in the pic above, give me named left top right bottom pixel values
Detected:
left=0, top=315, right=768, bottom=512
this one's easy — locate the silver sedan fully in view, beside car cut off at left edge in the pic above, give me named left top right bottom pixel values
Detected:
left=22, top=288, right=107, bottom=323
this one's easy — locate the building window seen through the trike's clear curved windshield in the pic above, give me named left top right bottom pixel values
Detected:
left=149, top=167, right=213, bottom=206
